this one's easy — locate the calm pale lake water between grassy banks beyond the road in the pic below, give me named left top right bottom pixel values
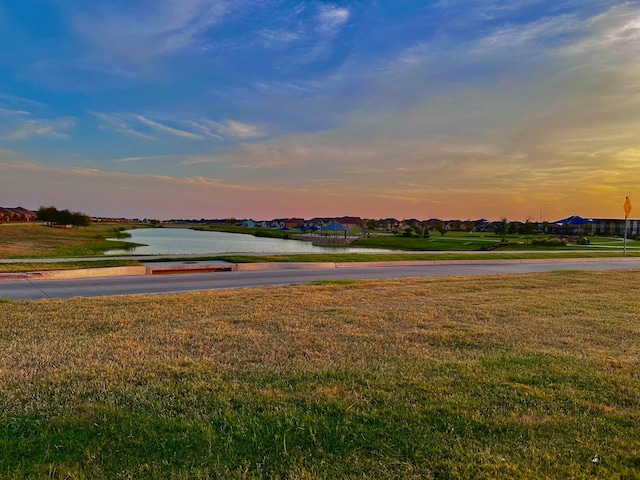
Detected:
left=105, top=228, right=391, bottom=255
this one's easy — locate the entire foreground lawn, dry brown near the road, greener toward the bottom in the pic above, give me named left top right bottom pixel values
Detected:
left=0, top=271, right=640, bottom=479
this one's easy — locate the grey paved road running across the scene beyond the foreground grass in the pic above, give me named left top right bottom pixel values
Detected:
left=0, top=259, right=640, bottom=299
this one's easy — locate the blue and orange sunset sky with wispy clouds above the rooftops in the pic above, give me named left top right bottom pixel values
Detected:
left=0, top=0, right=640, bottom=221
